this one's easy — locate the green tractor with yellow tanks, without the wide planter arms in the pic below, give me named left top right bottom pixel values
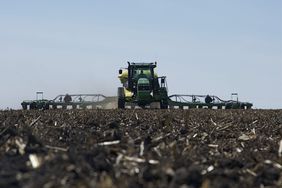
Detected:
left=118, top=62, right=168, bottom=109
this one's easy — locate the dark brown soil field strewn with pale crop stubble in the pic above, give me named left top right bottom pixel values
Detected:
left=0, top=109, right=282, bottom=188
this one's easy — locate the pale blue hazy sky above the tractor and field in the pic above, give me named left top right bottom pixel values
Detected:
left=0, top=0, right=282, bottom=109
